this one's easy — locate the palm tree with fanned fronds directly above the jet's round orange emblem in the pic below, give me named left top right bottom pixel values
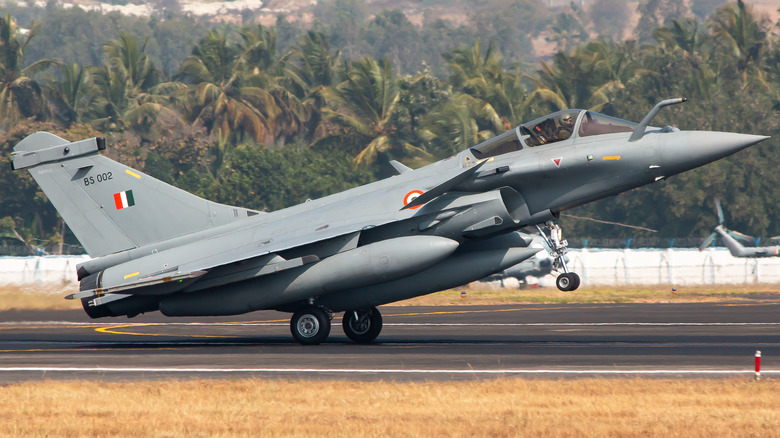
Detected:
left=319, top=56, right=429, bottom=165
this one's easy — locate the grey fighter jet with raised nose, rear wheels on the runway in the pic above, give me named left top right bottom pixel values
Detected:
left=11, top=99, right=768, bottom=344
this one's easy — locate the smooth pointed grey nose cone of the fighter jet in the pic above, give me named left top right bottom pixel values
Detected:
left=661, top=131, right=769, bottom=176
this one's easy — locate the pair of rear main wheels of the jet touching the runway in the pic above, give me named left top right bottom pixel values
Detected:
left=290, top=305, right=382, bottom=345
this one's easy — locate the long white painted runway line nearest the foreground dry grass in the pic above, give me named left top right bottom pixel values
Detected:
left=0, top=367, right=780, bottom=375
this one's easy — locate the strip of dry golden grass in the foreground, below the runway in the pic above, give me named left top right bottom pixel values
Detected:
left=0, top=378, right=780, bottom=437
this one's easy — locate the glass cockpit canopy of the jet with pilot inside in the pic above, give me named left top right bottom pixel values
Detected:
left=471, top=109, right=638, bottom=159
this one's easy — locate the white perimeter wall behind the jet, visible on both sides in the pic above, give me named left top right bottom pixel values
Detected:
left=0, top=248, right=780, bottom=286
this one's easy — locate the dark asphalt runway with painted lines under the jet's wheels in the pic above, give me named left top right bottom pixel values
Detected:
left=0, top=300, right=780, bottom=382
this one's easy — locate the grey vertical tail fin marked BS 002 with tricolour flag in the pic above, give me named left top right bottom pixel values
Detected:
left=11, top=132, right=257, bottom=257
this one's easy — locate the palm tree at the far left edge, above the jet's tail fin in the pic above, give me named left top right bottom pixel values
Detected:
left=0, top=14, right=53, bottom=125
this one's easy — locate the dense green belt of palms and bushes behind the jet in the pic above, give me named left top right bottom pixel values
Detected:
left=0, top=0, right=780, bottom=252
